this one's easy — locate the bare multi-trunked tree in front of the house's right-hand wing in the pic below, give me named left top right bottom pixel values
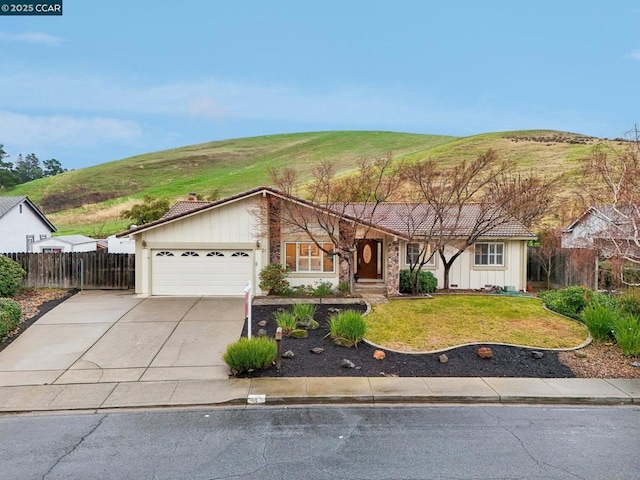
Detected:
left=403, top=150, right=558, bottom=290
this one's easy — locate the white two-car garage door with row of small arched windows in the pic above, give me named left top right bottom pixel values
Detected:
left=151, top=250, right=253, bottom=296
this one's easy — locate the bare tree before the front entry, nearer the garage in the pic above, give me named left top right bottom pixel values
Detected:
left=260, top=153, right=398, bottom=290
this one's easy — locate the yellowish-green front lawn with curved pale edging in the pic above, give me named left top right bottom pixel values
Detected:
left=366, top=295, right=588, bottom=352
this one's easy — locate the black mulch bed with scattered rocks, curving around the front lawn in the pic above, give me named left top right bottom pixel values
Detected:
left=239, top=305, right=575, bottom=378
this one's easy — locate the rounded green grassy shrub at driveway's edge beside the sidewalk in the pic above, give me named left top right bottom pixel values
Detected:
left=222, top=337, right=278, bottom=375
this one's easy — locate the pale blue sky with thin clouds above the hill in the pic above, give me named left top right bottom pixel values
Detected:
left=0, top=0, right=640, bottom=168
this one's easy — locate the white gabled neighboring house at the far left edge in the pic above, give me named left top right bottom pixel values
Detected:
left=0, top=196, right=56, bottom=253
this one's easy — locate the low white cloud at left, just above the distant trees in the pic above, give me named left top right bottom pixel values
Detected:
left=0, top=110, right=142, bottom=151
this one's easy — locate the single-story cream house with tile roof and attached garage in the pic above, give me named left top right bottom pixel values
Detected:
left=118, top=187, right=536, bottom=296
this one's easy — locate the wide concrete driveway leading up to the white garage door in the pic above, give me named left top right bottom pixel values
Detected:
left=0, top=291, right=244, bottom=386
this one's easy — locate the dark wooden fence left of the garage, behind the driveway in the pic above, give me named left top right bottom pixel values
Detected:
left=3, top=252, right=136, bottom=290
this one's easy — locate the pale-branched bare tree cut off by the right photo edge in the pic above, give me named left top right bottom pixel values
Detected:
left=583, top=125, right=640, bottom=285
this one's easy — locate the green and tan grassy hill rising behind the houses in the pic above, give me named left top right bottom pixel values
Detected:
left=5, top=130, right=598, bottom=236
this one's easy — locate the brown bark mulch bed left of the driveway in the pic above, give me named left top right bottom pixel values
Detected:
left=0, top=288, right=78, bottom=352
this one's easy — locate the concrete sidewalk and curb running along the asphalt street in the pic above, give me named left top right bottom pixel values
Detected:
left=0, top=377, right=640, bottom=413
